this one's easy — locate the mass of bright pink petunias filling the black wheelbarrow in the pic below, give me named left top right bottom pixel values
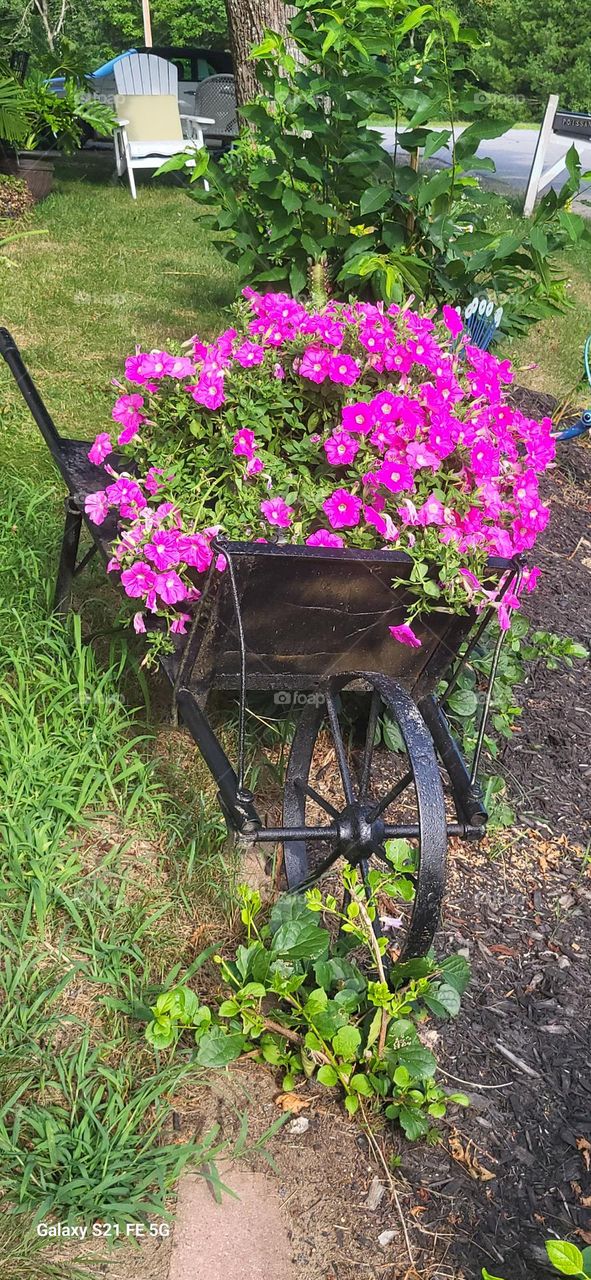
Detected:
left=87, top=289, right=555, bottom=645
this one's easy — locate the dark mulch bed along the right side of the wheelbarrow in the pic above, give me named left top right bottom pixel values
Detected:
left=400, top=393, right=591, bottom=1280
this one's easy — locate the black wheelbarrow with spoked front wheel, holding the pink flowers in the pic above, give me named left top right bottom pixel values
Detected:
left=0, top=329, right=522, bottom=960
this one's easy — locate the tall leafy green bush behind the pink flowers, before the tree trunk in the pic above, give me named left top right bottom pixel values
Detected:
left=173, top=0, right=585, bottom=326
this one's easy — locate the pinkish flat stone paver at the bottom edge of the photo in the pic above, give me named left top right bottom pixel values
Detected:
left=169, top=1169, right=297, bottom=1280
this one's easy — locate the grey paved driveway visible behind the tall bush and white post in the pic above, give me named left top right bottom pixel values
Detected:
left=380, top=129, right=591, bottom=218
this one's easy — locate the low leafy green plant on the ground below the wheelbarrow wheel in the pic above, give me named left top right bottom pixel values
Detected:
left=146, top=875, right=469, bottom=1139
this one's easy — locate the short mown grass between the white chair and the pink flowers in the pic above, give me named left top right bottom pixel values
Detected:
left=0, top=159, right=234, bottom=470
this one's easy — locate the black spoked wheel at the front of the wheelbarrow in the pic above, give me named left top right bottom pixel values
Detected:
left=283, top=672, right=446, bottom=960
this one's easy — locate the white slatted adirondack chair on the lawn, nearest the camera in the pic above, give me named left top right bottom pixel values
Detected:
left=114, top=54, right=214, bottom=200
